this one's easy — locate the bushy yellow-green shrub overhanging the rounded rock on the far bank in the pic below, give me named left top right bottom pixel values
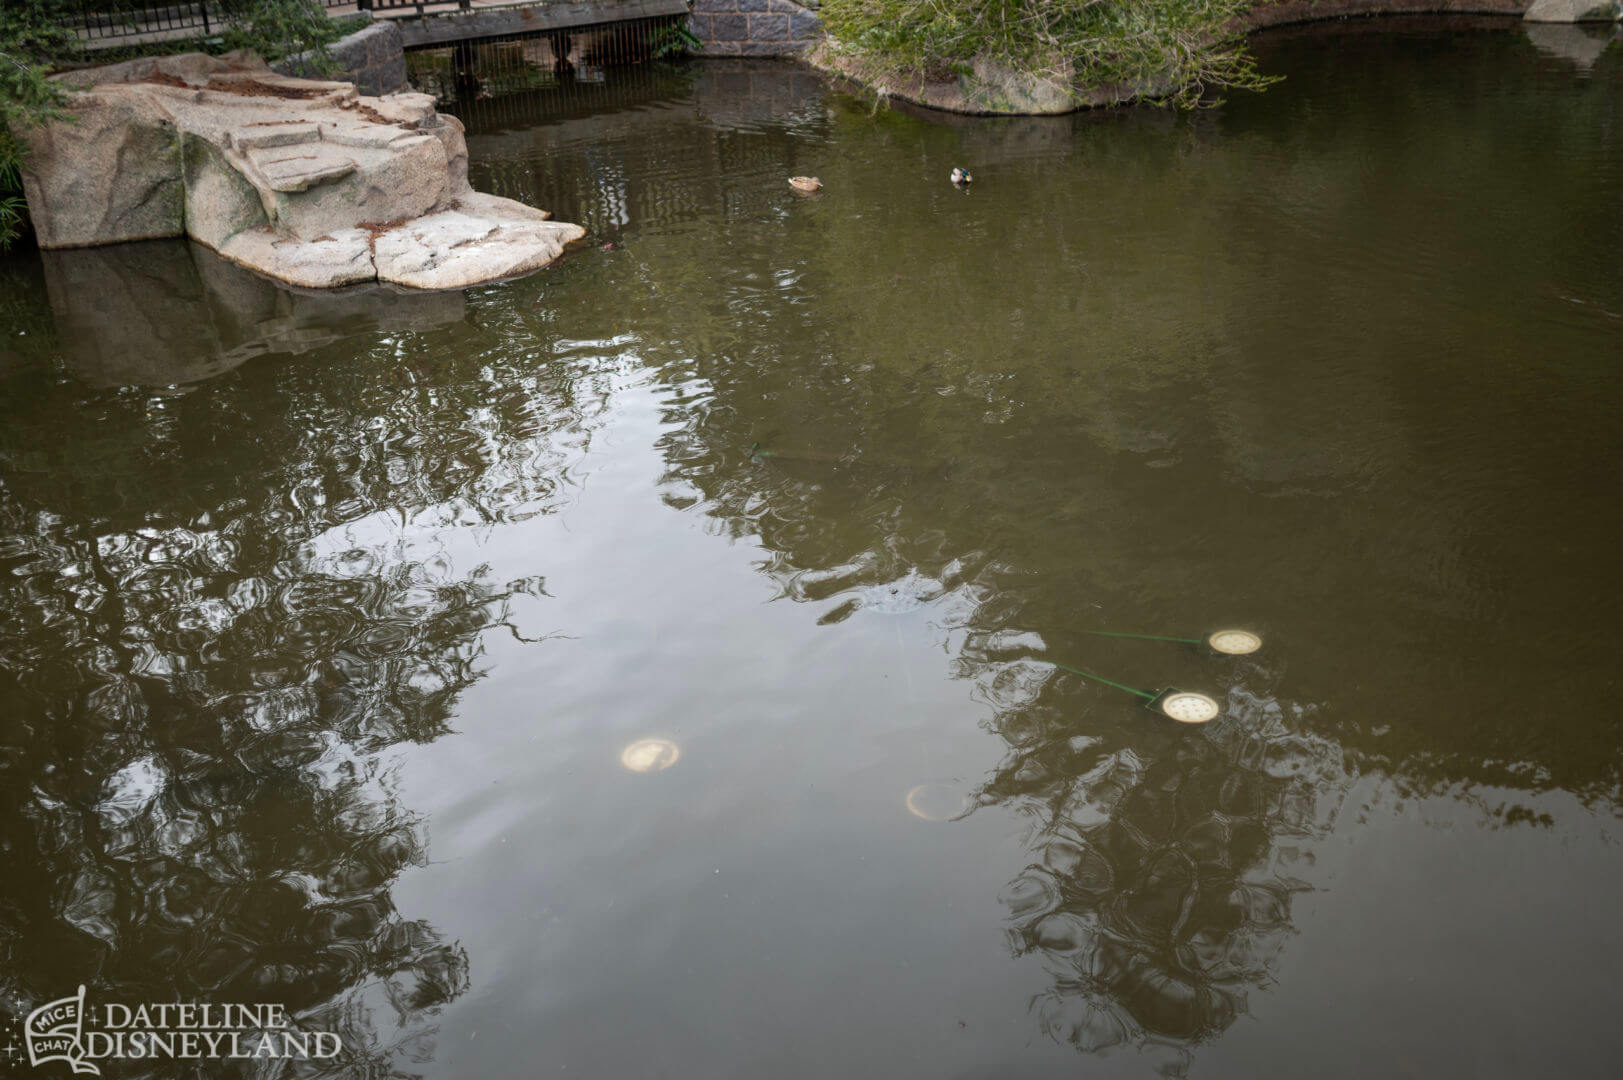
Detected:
left=820, top=0, right=1272, bottom=107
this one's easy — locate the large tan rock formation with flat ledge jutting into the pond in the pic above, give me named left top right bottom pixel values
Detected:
left=23, top=54, right=586, bottom=289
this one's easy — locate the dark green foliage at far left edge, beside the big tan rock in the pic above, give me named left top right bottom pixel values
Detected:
left=0, top=0, right=71, bottom=248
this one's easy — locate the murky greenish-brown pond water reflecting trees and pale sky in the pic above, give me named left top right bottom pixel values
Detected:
left=0, top=23, right=1623, bottom=1080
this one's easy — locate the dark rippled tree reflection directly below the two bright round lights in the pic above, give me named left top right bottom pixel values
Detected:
left=977, top=671, right=1334, bottom=1051
